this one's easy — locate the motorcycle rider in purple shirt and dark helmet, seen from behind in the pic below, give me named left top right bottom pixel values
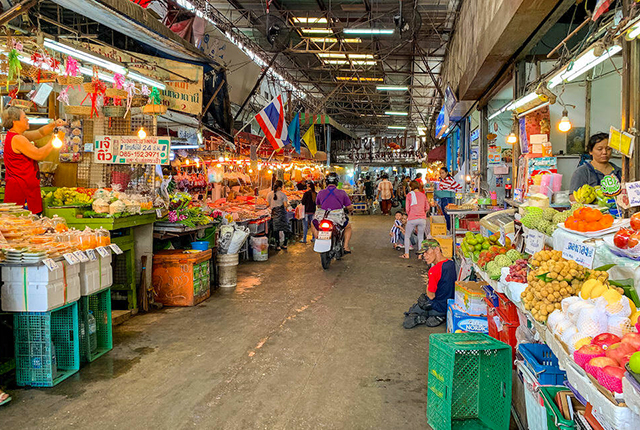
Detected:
left=314, top=172, right=353, bottom=254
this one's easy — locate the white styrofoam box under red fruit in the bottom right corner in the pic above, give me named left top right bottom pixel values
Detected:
left=566, top=361, right=640, bottom=430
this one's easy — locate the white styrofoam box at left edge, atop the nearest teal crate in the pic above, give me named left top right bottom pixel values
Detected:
left=2, top=262, right=80, bottom=312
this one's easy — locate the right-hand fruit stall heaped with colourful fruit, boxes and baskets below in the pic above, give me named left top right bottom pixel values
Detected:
left=448, top=193, right=640, bottom=430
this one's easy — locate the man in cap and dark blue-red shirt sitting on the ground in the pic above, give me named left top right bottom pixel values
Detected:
left=403, top=239, right=458, bottom=328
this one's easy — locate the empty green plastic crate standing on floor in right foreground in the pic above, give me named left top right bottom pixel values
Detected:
left=427, top=333, right=511, bottom=430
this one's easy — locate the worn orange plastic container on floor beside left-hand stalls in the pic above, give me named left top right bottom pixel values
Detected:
left=152, top=249, right=212, bottom=306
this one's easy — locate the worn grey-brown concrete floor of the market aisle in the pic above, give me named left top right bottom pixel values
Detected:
left=0, top=216, right=444, bottom=430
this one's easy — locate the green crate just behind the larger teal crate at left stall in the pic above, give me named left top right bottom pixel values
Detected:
left=79, top=289, right=113, bottom=363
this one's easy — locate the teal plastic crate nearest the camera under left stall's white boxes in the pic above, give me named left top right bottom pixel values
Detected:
left=13, top=302, right=80, bottom=387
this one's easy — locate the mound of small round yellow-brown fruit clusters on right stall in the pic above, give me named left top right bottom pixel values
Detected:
left=522, top=251, right=588, bottom=322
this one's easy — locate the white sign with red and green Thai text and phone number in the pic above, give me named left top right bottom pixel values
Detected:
left=93, top=136, right=171, bottom=164
